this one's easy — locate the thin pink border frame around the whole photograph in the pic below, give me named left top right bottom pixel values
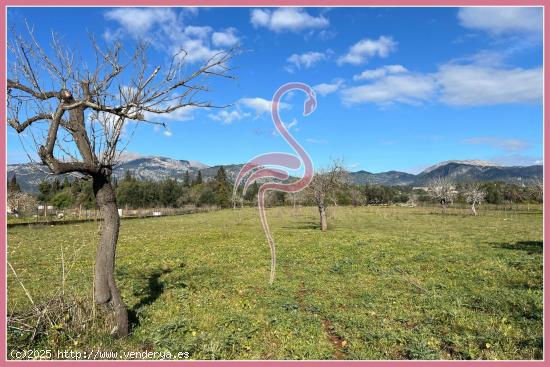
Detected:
left=0, top=0, right=550, bottom=367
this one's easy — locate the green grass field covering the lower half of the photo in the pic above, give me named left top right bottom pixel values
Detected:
left=8, top=207, right=543, bottom=359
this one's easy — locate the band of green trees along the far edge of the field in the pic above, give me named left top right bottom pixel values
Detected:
left=7, top=167, right=543, bottom=211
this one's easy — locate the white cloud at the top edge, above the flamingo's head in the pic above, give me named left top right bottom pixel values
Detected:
left=250, top=8, right=329, bottom=32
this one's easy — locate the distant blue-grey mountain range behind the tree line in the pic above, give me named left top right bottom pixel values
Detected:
left=8, top=157, right=542, bottom=192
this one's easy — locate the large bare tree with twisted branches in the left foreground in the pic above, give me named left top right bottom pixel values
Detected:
left=7, top=27, right=235, bottom=337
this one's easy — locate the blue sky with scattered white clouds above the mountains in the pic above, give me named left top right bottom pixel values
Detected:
left=8, top=7, right=543, bottom=172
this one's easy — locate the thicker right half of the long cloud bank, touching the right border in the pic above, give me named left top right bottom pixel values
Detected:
left=437, top=64, right=543, bottom=106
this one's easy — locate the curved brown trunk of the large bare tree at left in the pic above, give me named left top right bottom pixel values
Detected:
left=93, top=175, right=128, bottom=337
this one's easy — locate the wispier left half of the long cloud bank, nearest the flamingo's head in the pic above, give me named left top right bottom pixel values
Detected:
left=341, top=74, right=437, bottom=105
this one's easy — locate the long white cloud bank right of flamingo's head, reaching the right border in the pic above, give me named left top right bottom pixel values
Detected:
left=341, top=63, right=543, bottom=106
